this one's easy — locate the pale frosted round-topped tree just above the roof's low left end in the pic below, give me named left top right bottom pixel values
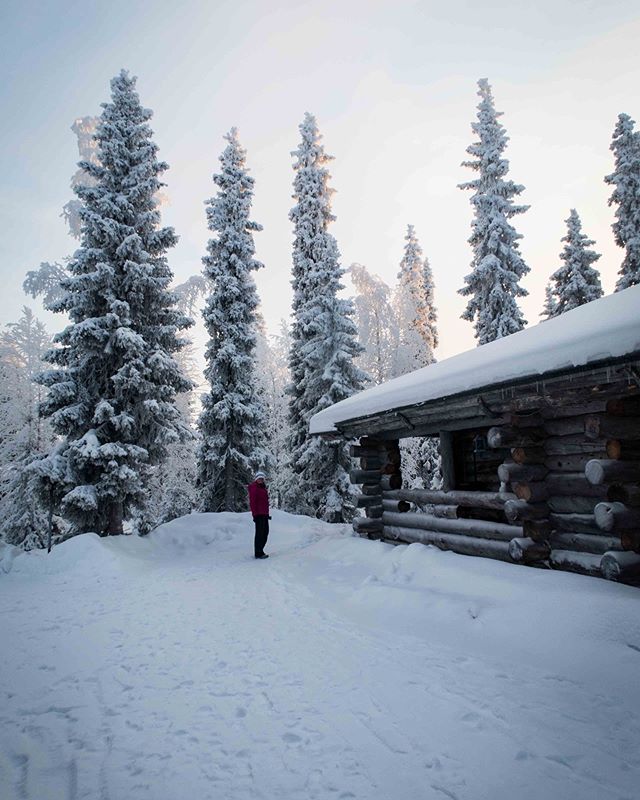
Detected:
left=349, top=264, right=398, bottom=384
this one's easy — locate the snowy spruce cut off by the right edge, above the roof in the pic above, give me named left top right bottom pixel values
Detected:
left=605, top=114, right=640, bottom=292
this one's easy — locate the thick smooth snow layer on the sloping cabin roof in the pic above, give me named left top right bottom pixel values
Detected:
left=309, top=286, right=640, bottom=433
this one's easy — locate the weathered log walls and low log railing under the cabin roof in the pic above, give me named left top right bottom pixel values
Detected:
left=351, top=391, right=640, bottom=582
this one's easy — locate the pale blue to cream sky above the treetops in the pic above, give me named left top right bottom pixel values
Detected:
left=0, top=0, right=640, bottom=359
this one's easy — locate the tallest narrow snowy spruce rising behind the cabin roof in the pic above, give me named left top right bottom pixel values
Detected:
left=458, top=78, right=529, bottom=344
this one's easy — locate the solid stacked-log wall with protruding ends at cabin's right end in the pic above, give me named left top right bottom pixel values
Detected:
left=489, top=398, right=640, bottom=580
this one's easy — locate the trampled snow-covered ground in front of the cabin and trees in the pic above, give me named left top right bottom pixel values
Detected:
left=0, top=512, right=640, bottom=800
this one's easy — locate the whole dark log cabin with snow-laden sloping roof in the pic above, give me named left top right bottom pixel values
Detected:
left=310, top=286, right=640, bottom=582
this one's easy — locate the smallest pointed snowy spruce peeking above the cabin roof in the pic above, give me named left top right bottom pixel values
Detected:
left=545, top=208, right=602, bottom=317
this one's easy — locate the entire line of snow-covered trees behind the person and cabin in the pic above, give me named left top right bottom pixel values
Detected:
left=0, top=71, right=640, bottom=549
